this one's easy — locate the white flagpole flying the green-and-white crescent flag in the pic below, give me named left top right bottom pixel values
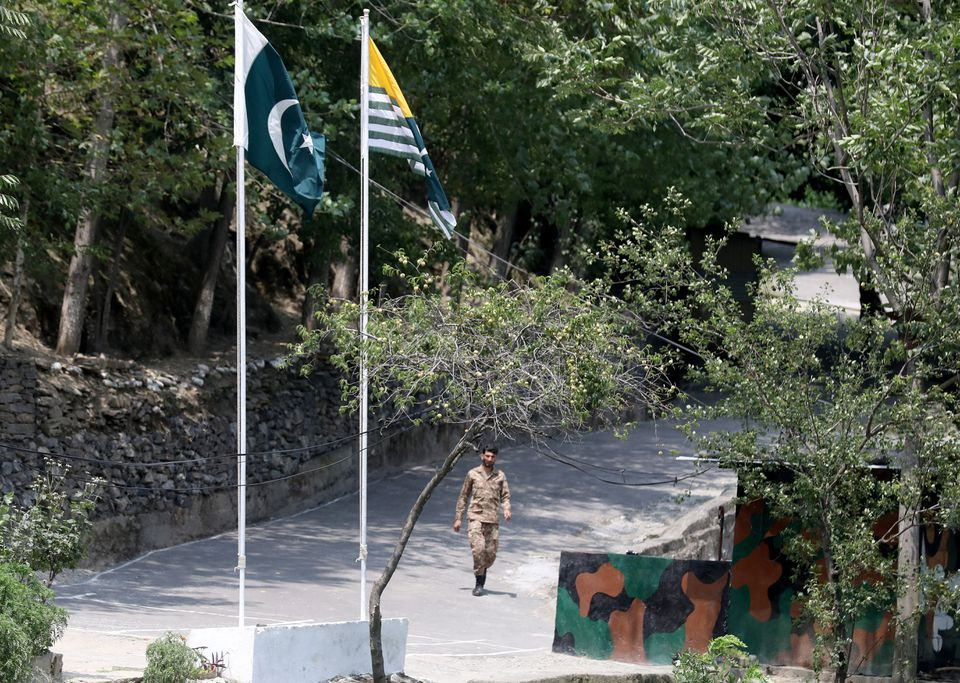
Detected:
left=233, top=0, right=247, bottom=628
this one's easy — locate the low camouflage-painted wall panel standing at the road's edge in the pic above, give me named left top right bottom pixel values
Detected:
left=553, top=552, right=730, bottom=664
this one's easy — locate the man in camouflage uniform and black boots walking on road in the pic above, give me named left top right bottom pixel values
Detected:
left=453, top=446, right=510, bottom=596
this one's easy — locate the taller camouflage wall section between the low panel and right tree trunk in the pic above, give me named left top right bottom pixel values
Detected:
left=727, top=501, right=893, bottom=676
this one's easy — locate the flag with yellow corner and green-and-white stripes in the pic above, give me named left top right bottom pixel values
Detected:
left=367, top=39, right=457, bottom=239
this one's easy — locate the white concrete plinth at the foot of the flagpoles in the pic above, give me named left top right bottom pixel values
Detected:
left=187, top=619, right=407, bottom=683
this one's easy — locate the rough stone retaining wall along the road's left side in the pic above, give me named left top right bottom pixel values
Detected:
left=0, top=355, right=455, bottom=567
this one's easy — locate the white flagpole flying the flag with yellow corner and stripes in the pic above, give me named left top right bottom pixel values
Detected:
left=357, top=9, right=370, bottom=621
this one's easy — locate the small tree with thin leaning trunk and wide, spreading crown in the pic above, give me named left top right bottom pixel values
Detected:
left=295, top=254, right=669, bottom=681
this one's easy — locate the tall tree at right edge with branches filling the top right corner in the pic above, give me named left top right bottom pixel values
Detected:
left=546, top=0, right=960, bottom=680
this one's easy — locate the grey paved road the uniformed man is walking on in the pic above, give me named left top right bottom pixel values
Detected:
left=54, top=422, right=734, bottom=683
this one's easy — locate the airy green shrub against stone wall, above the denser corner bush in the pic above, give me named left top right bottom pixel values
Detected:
left=0, top=461, right=100, bottom=586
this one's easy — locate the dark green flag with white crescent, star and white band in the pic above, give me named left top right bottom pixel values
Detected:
left=233, top=12, right=325, bottom=217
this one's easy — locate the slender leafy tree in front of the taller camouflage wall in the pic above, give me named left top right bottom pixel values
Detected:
left=603, top=195, right=960, bottom=683
